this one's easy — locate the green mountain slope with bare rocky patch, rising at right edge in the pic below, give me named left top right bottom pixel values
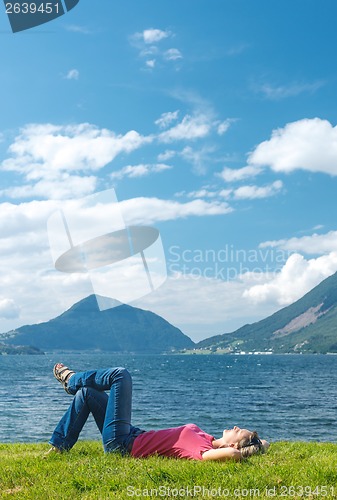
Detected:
left=195, top=273, right=337, bottom=354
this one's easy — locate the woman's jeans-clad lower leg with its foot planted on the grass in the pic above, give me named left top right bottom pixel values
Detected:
left=49, top=387, right=108, bottom=450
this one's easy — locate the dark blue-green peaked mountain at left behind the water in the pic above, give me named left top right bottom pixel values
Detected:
left=2, top=295, right=194, bottom=353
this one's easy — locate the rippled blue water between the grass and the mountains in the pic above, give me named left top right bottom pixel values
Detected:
left=0, top=352, right=337, bottom=443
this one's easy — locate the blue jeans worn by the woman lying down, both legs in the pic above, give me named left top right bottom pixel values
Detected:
left=49, top=368, right=144, bottom=455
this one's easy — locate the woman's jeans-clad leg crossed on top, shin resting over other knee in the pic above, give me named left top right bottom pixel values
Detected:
left=67, top=368, right=143, bottom=454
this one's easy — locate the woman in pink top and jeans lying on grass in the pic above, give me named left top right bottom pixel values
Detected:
left=48, top=363, right=269, bottom=460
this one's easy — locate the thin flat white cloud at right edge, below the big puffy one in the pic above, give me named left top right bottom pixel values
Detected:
left=260, top=231, right=337, bottom=255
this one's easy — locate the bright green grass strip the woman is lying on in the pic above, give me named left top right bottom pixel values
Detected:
left=0, top=441, right=337, bottom=500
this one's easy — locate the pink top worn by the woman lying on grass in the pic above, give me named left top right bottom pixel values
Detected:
left=131, top=424, right=214, bottom=460
